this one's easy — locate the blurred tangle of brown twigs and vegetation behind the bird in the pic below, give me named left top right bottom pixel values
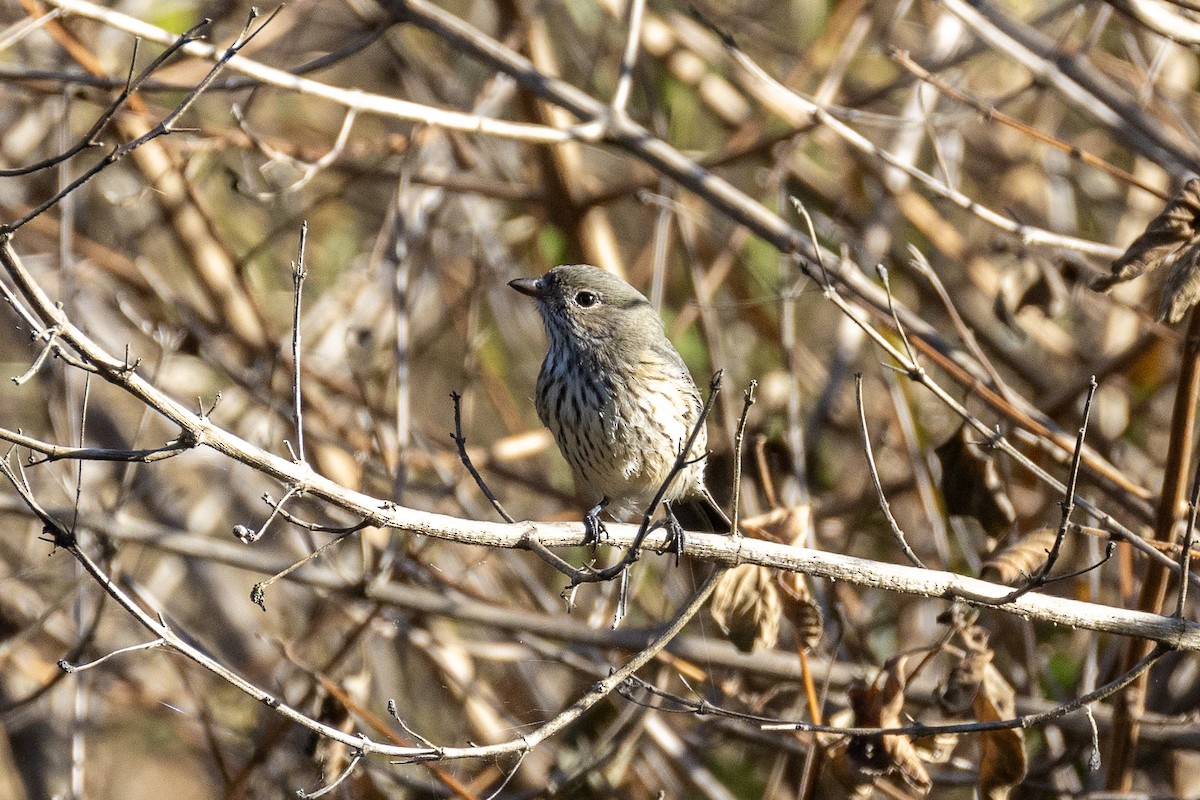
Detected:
left=0, top=0, right=1200, bottom=800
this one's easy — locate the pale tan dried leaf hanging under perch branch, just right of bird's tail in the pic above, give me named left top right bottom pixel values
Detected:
left=709, top=564, right=782, bottom=652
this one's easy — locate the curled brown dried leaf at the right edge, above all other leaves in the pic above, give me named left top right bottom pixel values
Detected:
left=1092, top=178, right=1200, bottom=323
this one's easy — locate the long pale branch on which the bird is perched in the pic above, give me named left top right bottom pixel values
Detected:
left=0, top=236, right=1200, bottom=650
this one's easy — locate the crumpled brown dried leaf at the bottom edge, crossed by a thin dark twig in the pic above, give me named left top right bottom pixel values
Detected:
left=846, top=656, right=931, bottom=793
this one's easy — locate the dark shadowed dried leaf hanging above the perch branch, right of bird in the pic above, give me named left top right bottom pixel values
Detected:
left=934, top=425, right=1016, bottom=534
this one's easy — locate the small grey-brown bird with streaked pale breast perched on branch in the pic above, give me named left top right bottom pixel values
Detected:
left=509, top=264, right=725, bottom=557
